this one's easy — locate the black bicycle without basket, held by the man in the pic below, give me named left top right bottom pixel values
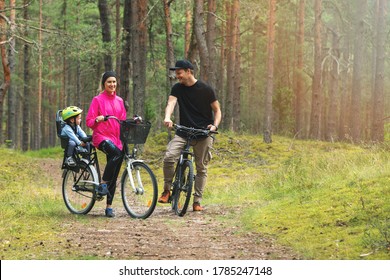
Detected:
left=169, top=124, right=218, bottom=217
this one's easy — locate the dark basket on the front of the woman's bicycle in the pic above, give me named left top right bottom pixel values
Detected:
left=121, top=119, right=151, bottom=144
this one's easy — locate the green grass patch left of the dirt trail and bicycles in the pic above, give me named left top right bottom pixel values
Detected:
left=0, top=149, right=61, bottom=259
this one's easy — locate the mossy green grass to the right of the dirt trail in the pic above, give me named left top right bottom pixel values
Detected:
left=207, top=135, right=390, bottom=259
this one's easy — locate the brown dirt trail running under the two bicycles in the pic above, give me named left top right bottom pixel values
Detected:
left=44, top=160, right=299, bottom=260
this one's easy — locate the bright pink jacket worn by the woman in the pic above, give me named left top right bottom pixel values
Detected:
left=86, top=91, right=126, bottom=149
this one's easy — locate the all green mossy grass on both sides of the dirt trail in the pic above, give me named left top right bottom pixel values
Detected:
left=0, top=133, right=390, bottom=260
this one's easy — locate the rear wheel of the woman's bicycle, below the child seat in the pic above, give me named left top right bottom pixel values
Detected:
left=62, top=162, right=99, bottom=214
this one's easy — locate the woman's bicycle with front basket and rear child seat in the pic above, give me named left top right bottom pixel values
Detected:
left=56, top=110, right=158, bottom=219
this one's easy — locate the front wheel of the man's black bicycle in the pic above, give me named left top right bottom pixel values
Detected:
left=174, top=160, right=194, bottom=217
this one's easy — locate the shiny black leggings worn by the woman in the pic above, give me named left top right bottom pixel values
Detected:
left=99, top=140, right=123, bottom=204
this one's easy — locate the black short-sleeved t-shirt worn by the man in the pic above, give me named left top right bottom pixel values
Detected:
left=171, top=80, right=217, bottom=129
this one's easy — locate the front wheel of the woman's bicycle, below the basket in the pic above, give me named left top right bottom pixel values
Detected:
left=121, top=161, right=158, bottom=219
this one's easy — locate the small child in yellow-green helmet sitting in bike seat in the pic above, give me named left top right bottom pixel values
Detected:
left=61, top=106, right=90, bottom=166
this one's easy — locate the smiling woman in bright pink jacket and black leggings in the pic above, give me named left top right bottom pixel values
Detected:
left=86, top=71, right=126, bottom=218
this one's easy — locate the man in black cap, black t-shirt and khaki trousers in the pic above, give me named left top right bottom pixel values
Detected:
left=158, top=60, right=222, bottom=211
